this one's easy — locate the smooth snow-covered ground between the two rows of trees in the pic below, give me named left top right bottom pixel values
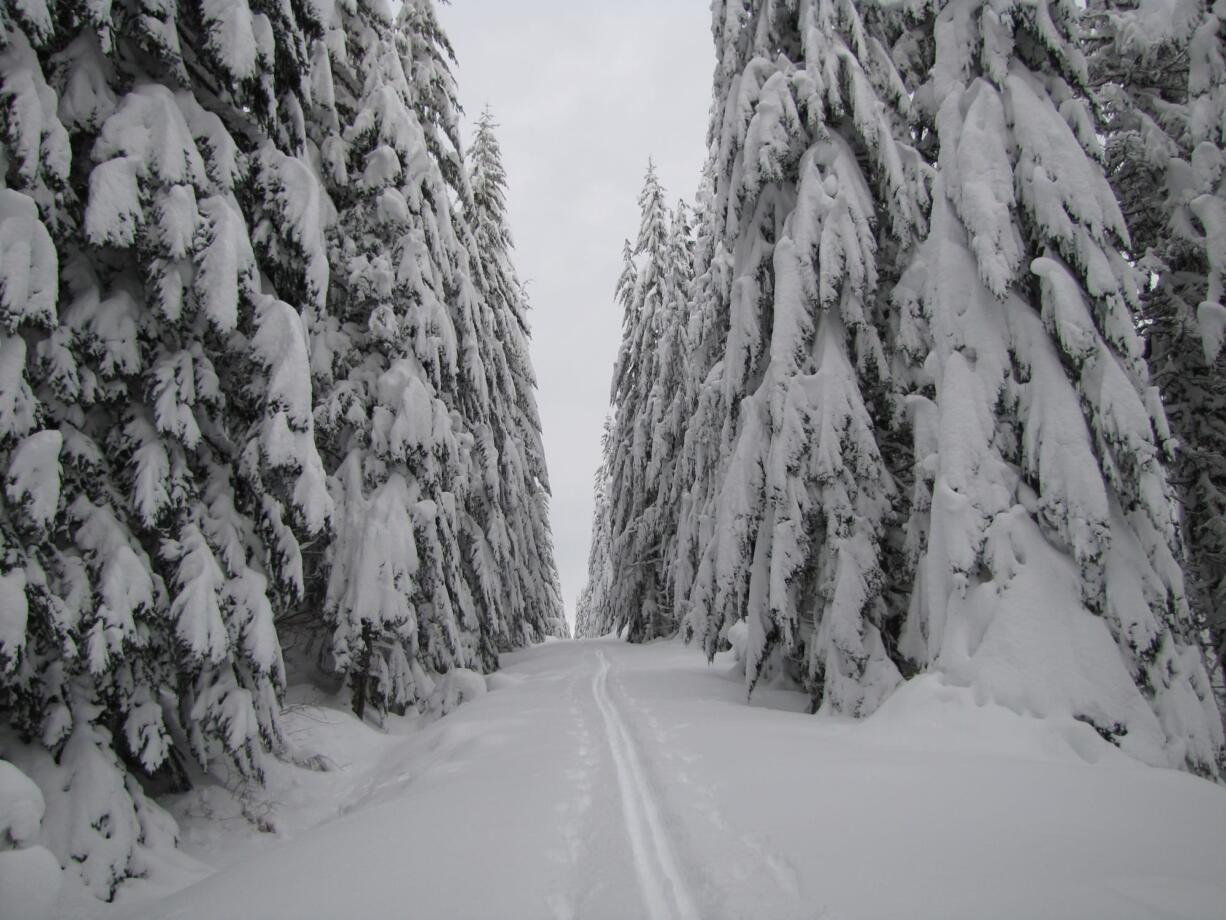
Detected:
left=52, top=640, right=1226, bottom=920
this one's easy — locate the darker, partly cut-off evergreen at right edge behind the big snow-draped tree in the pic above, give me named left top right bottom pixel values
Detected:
left=1090, top=0, right=1226, bottom=711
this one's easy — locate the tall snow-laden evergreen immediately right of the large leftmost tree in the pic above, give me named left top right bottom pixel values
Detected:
left=316, top=1, right=478, bottom=715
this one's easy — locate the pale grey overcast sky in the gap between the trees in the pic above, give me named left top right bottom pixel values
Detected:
left=439, top=0, right=715, bottom=623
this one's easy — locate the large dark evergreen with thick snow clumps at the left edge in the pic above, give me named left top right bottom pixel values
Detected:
left=0, top=1, right=330, bottom=897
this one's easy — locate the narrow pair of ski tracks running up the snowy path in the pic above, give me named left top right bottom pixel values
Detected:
left=592, top=650, right=699, bottom=920
